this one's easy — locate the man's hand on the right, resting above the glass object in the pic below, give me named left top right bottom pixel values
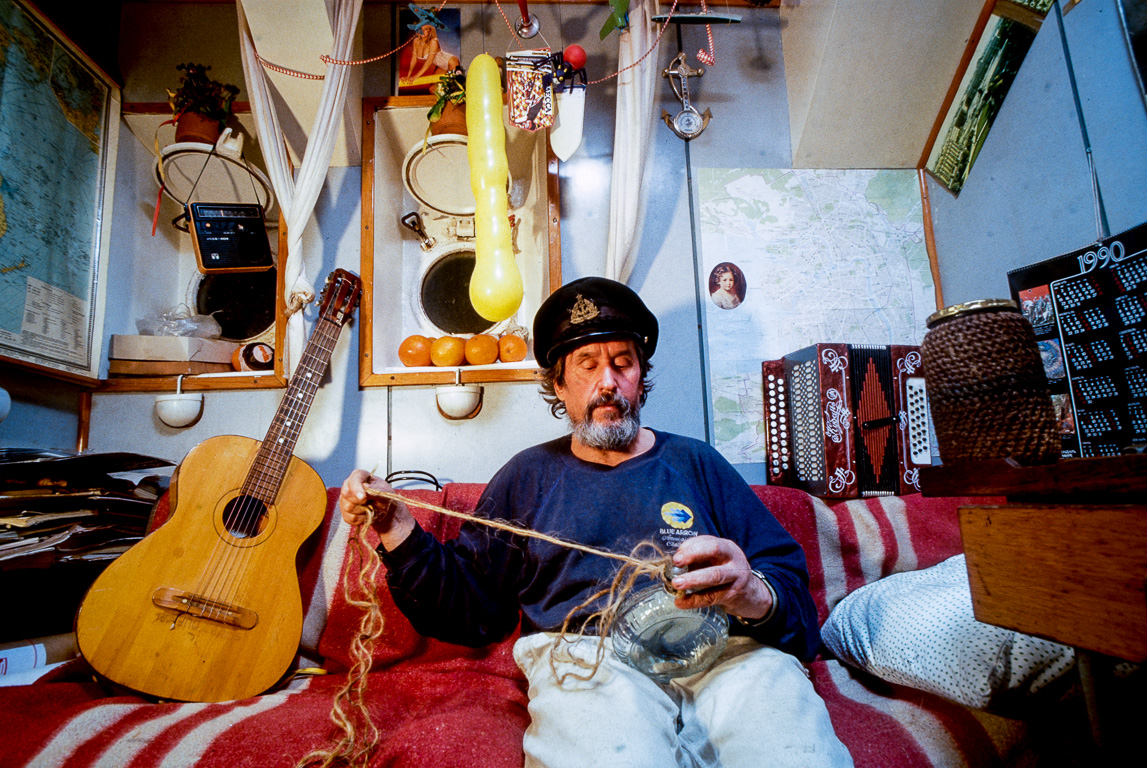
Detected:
left=673, top=536, right=773, bottom=620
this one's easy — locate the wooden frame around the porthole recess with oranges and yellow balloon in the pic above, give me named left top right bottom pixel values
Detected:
left=359, top=96, right=562, bottom=387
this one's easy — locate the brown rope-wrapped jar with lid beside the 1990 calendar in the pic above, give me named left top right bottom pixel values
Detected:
left=920, top=299, right=1060, bottom=464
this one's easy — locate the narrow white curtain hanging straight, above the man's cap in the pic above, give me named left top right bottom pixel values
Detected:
left=604, top=0, right=657, bottom=283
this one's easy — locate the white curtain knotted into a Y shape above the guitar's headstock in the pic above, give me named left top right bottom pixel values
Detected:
left=235, top=0, right=362, bottom=376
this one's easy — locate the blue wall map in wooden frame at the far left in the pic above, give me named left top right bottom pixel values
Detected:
left=0, top=1, right=122, bottom=386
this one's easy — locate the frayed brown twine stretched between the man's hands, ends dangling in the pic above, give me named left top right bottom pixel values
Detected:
left=296, top=487, right=672, bottom=768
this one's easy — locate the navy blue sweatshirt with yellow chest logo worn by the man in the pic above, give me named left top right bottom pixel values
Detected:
left=381, top=431, right=820, bottom=660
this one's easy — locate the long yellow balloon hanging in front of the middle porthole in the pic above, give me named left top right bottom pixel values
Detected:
left=466, top=54, right=522, bottom=322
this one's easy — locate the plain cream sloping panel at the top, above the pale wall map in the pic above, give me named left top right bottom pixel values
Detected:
left=781, top=0, right=984, bottom=169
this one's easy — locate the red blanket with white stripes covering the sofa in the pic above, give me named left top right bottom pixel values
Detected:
left=0, top=484, right=1064, bottom=768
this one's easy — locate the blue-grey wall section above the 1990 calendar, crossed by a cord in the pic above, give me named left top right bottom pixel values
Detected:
left=928, top=0, right=1147, bottom=305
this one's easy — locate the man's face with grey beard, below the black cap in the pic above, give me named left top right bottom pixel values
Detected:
left=554, top=339, right=642, bottom=449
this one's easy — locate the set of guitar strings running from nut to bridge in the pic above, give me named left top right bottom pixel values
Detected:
left=188, top=316, right=342, bottom=620
